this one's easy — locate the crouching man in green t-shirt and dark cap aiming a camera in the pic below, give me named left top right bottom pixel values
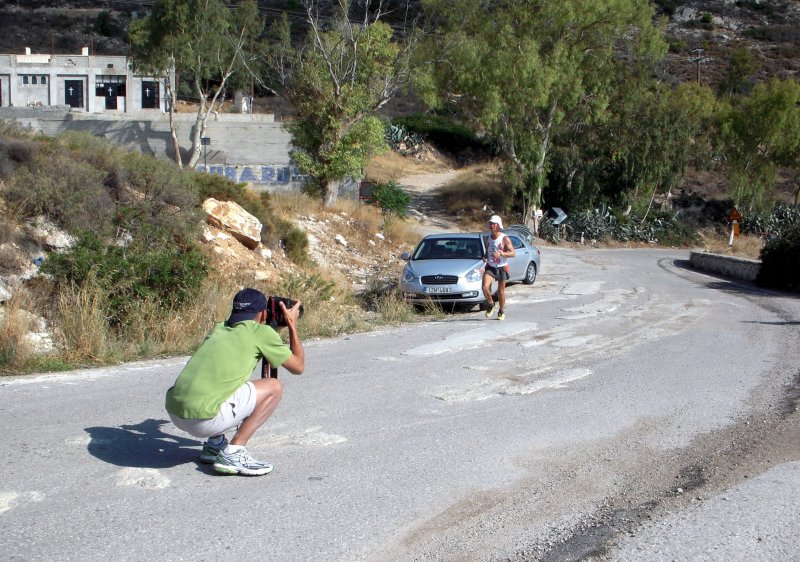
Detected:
left=166, top=289, right=305, bottom=476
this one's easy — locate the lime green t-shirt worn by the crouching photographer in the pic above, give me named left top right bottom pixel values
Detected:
left=166, top=320, right=292, bottom=419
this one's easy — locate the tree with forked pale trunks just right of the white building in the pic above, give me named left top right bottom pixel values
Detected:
left=130, top=0, right=264, bottom=168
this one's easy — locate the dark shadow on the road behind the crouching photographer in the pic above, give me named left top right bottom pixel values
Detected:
left=85, top=419, right=202, bottom=468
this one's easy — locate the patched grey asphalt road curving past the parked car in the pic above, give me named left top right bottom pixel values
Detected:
left=0, top=248, right=800, bottom=561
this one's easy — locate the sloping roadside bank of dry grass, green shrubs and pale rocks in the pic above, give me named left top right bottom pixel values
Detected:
left=0, top=123, right=424, bottom=372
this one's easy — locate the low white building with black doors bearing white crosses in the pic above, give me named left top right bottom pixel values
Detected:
left=0, top=47, right=167, bottom=113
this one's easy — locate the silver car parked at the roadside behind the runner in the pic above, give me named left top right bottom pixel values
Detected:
left=400, top=226, right=540, bottom=309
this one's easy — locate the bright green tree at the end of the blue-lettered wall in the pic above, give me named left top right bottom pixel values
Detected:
left=269, top=0, right=416, bottom=206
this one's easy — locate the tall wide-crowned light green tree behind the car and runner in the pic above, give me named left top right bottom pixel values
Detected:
left=419, top=0, right=666, bottom=228
